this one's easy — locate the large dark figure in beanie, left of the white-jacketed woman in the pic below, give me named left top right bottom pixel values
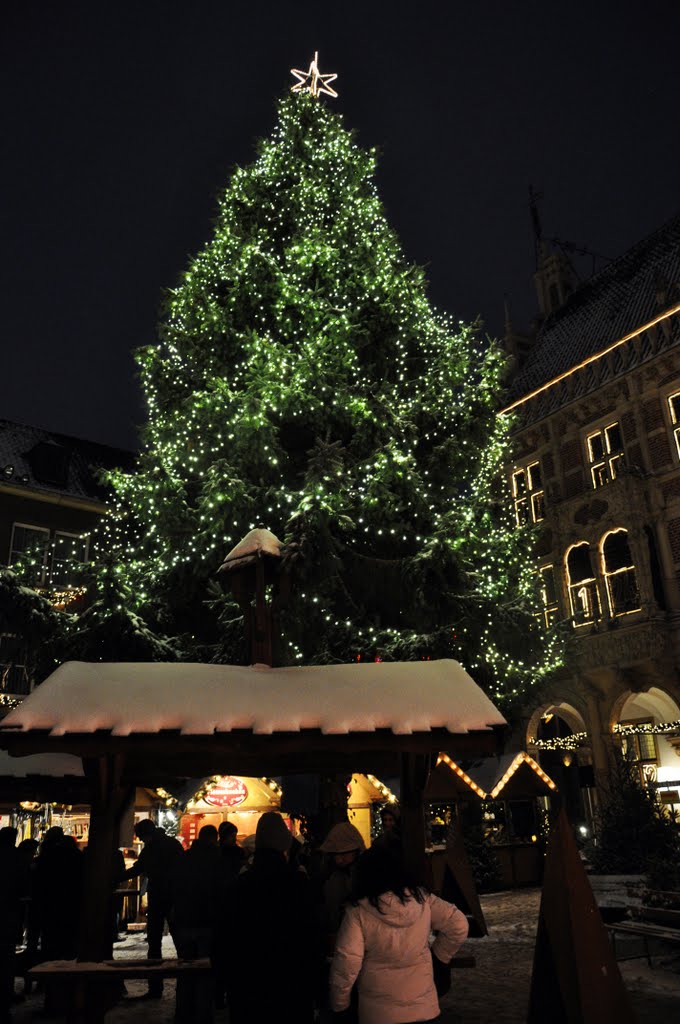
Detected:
left=222, top=811, right=321, bottom=1024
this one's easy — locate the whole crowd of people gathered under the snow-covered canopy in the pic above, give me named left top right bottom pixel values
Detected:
left=0, top=805, right=468, bottom=1024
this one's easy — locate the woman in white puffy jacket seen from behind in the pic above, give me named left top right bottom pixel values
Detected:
left=330, top=850, right=468, bottom=1024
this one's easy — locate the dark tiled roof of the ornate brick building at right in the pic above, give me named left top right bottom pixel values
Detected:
left=506, top=214, right=680, bottom=404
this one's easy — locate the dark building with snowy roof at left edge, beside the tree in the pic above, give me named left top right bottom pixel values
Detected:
left=0, top=420, right=133, bottom=714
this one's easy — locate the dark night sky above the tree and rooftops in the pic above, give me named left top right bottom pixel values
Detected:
left=0, top=0, right=680, bottom=445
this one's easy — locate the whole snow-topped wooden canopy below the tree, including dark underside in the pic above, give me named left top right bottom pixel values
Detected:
left=0, top=659, right=505, bottom=784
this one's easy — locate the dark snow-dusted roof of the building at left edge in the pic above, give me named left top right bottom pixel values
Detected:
left=0, top=420, right=134, bottom=502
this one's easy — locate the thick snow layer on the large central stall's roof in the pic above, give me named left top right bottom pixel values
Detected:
left=0, top=659, right=505, bottom=746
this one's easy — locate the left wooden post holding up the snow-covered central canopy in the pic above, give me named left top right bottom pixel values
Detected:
left=78, top=754, right=133, bottom=962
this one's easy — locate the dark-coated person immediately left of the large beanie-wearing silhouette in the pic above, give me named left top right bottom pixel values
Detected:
left=170, top=825, right=224, bottom=1024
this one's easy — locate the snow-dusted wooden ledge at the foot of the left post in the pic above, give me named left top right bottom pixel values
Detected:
left=28, top=957, right=212, bottom=1024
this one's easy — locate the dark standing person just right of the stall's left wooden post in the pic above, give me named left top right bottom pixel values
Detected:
left=125, top=818, right=183, bottom=999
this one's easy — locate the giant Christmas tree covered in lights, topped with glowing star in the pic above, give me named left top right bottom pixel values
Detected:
left=98, top=65, right=555, bottom=698
